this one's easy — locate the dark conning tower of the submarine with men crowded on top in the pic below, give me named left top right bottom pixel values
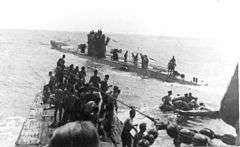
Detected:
left=87, top=30, right=110, bottom=58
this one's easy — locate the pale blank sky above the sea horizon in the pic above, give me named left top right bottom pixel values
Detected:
left=0, top=0, right=240, bottom=37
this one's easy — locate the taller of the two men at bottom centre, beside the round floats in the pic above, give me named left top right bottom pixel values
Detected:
left=121, top=109, right=137, bottom=147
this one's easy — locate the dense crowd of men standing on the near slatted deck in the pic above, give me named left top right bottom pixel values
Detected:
left=44, top=55, right=120, bottom=140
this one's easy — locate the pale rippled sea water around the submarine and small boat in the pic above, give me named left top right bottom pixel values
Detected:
left=0, top=30, right=236, bottom=147
